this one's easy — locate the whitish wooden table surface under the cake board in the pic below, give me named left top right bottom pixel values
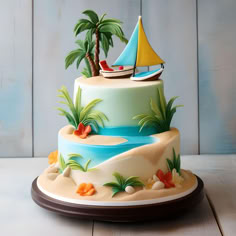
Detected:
left=0, top=155, right=236, bottom=236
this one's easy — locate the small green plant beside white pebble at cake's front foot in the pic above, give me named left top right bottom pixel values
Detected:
left=103, top=172, right=144, bottom=197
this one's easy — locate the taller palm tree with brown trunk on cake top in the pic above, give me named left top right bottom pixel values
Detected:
left=66, top=10, right=128, bottom=76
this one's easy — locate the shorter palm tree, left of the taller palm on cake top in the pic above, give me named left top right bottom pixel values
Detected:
left=65, top=38, right=96, bottom=77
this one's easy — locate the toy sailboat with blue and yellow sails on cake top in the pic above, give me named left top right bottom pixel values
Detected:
left=101, top=16, right=165, bottom=81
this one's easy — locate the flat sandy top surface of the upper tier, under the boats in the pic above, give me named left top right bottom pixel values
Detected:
left=76, top=76, right=162, bottom=88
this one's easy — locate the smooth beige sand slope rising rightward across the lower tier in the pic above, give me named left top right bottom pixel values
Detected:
left=71, top=128, right=180, bottom=186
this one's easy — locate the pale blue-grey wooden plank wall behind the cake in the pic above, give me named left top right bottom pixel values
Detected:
left=0, top=0, right=236, bottom=157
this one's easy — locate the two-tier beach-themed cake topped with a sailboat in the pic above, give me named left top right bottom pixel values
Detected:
left=33, top=11, right=201, bottom=220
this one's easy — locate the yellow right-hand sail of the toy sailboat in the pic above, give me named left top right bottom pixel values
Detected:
left=136, top=17, right=165, bottom=66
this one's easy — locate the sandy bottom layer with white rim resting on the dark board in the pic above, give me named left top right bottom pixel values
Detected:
left=37, top=170, right=197, bottom=206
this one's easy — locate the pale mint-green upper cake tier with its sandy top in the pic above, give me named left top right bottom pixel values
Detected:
left=74, top=76, right=163, bottom=127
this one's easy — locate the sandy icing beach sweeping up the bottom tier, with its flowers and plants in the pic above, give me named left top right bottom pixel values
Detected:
left=41, top=126, right=196, bottom=201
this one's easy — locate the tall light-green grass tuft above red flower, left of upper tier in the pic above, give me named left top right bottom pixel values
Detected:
left=57, top=86, right=108, bottom=132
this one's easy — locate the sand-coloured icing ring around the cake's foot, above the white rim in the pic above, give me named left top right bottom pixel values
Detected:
left=38, top=169, right=197, bottom=202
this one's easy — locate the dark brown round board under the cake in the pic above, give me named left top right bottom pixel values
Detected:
left=31, top=177, right=204, bottom=222
